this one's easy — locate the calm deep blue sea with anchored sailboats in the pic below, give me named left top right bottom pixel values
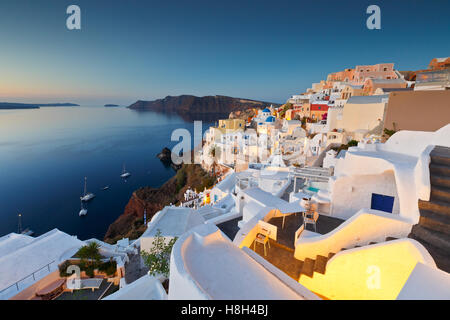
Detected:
left=0, top=107, right=212, bottom=240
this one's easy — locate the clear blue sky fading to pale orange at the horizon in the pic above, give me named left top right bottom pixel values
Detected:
left=0, top=0, right=450, bottom=105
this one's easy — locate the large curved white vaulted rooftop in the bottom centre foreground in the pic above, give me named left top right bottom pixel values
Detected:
left=176, top=224, right=310, bottom=300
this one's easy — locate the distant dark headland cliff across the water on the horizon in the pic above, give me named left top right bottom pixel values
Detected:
left=128, top=95, right=279, bottom=115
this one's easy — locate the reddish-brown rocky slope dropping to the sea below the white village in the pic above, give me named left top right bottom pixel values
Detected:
left=104, top=164, right=215, bottom=243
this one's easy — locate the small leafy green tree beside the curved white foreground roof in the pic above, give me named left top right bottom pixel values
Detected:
left=141, top=229, right=177, bottom=277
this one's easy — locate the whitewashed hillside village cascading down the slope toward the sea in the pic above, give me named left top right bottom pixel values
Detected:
left=0, top=57, right=450, bottom=300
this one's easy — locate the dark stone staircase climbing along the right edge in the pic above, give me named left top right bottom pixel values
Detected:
left=408, top=146, right=450, bottom=272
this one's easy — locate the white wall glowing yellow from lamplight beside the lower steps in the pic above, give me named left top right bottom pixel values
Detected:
left=299, top=239, right=435, bottom=300
